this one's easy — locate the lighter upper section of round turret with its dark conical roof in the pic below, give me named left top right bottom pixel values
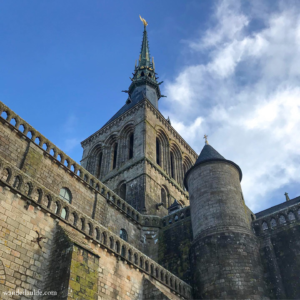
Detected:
left=185, top=144, right=249, bottom=239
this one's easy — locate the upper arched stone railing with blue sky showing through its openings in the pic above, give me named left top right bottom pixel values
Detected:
left=0, top=102, right=143, bottom=224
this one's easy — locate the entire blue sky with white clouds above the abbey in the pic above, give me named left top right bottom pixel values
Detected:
left=0, top=0, right=300, bottom=212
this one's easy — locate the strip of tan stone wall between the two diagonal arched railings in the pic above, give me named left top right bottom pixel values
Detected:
left=0, top=106, right=142, bottom=249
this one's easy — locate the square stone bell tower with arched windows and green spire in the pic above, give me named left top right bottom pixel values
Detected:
left=81, top=19, right=197, bottom=216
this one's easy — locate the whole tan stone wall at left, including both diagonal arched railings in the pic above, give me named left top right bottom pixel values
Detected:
left=0, top=103, right=191, bottom=299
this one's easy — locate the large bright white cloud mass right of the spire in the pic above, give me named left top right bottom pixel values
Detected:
left=164, top=0, right=300, bottom=211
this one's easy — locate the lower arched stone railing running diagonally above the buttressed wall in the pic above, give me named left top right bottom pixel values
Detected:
left=0, top=158, right=191, bottom=299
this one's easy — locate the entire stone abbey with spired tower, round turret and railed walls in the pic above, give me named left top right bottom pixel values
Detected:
left=0, top=20, right=300, bottom=300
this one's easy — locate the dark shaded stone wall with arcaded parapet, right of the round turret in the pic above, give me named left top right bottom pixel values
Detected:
left=252, top=199, right=300, bottom=299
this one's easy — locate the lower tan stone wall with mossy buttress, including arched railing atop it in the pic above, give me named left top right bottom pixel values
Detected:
left=0, top=170, right=190, bottom=299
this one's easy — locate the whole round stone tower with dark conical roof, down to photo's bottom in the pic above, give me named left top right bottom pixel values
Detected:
left=185, top=144, right=265, bottom=299
